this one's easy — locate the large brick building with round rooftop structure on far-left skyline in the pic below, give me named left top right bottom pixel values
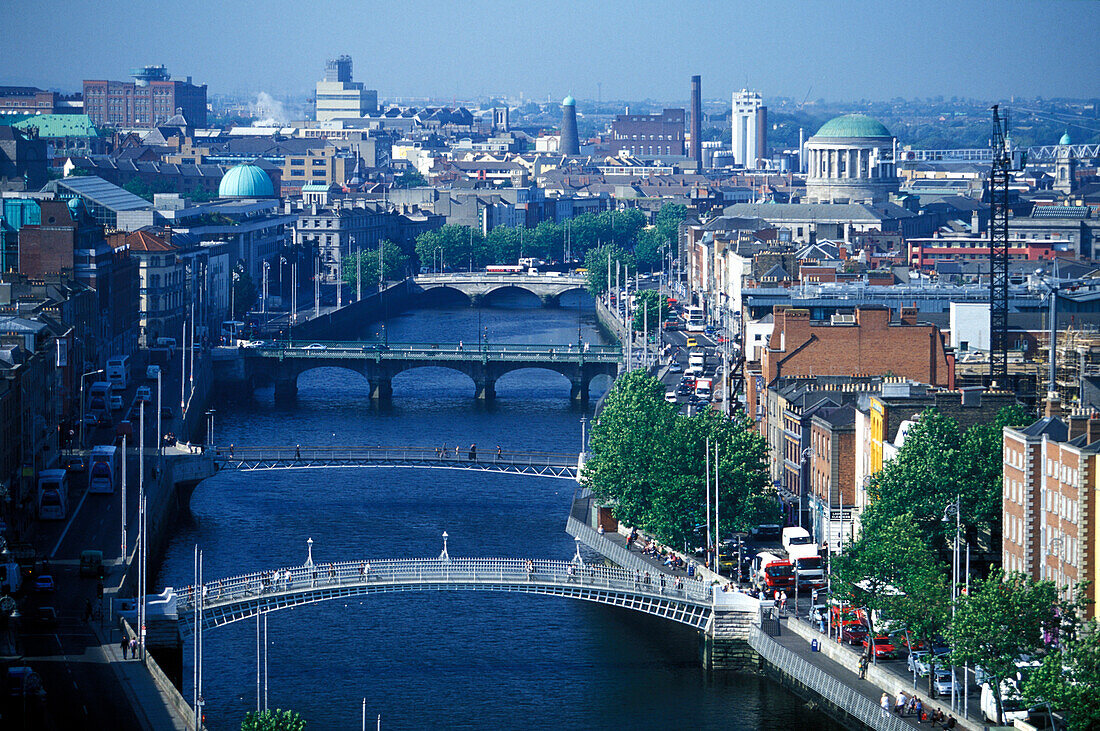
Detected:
left=84, top=66, right=207, bottom=128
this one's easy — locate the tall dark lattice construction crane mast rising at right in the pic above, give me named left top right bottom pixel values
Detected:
left=989, top=104, right=1025, bottom=388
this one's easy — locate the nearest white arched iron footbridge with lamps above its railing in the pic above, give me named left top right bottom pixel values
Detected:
left=174, top=554, right=721, bottom=631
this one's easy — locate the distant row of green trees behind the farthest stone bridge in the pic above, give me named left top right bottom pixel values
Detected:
left=416, top=203, right=688, bottom=280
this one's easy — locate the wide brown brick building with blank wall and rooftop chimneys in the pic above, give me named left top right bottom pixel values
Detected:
left=761, top=307, right=955, bottom=388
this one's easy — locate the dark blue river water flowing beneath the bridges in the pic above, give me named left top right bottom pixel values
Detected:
left=157, top=290, right=839, bottom=731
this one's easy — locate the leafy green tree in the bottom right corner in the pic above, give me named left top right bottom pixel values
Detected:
left=1023, top=619, right=1100, bottom=731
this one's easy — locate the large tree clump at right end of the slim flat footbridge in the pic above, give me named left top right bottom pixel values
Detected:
left=584, top=370, right=779, bottom=545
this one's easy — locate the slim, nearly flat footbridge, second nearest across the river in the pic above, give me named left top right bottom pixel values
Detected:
left=206, top=445, right=580, bottom=479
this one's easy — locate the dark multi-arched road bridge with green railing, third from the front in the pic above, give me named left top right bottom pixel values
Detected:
left=213, top=342, right=623, bottom=401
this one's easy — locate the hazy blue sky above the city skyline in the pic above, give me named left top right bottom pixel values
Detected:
left=0, top=0, right=1100, bottom=101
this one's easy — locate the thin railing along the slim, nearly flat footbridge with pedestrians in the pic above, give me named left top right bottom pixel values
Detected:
left=207, top=445, right=578, bottom=467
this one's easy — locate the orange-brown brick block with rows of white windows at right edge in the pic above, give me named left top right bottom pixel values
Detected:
left=1001, top=413, right=1100, bottom=617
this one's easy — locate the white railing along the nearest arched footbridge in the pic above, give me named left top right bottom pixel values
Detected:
left=176, top=558, right=712, bottom=614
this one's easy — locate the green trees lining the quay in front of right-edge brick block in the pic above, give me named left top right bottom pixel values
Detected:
left=832, top=407, right=1100, bottom=729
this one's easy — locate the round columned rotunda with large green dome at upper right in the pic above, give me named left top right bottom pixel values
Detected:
left=803, top=114, right=898, bottom=204
